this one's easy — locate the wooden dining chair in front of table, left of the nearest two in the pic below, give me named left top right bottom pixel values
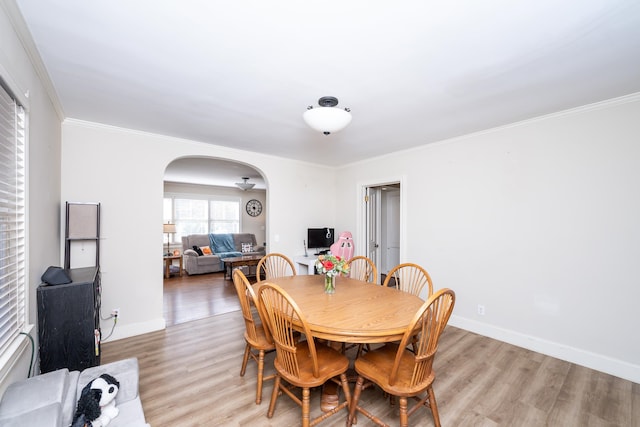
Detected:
left=259, top=283, right=351, bottom=427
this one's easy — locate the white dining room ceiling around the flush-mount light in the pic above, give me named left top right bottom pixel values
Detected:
left=10, top=0, right=640, bottom=181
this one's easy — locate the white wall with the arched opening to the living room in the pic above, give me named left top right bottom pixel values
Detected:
left=61, top=120, right=334, bottom=339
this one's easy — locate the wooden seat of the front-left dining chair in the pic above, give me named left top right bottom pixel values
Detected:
left=274, top=341, right=349, bottom=387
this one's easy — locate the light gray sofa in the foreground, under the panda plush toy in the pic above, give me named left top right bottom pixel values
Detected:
left=0, top=358, right=149, bottom=427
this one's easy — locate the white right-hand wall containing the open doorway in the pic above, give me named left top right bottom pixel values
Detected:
left=337, top=95, right=640, bottom=382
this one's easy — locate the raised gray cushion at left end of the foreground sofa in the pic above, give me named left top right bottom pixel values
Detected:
left=0, top=368, right=70, bottom=418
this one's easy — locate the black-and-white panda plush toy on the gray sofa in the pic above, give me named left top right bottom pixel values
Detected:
left=71, top=374, right=120, bottom=427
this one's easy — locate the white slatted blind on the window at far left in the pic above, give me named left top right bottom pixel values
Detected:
left=0, top=82, right=26, bottom=362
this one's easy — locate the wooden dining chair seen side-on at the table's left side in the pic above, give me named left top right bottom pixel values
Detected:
left=233, top=269, right=276, bottom=405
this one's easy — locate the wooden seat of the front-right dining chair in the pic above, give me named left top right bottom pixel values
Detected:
left=354, top=343, right=435, bottom=397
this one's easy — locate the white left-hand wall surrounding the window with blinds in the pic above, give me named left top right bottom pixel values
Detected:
left=0, top=2, right=61, bottom=394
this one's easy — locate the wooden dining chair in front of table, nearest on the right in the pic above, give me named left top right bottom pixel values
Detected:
left=347, top=289, right=455, bottom=427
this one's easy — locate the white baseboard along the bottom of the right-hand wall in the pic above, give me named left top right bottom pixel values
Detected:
left=449, top=315, right=640, bottom=383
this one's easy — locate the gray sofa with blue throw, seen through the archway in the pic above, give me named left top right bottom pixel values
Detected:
left=182, top=233, right=266, bottom=275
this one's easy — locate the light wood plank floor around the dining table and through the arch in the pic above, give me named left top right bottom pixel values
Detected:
left=102, top=275, right=640, bottom=427
